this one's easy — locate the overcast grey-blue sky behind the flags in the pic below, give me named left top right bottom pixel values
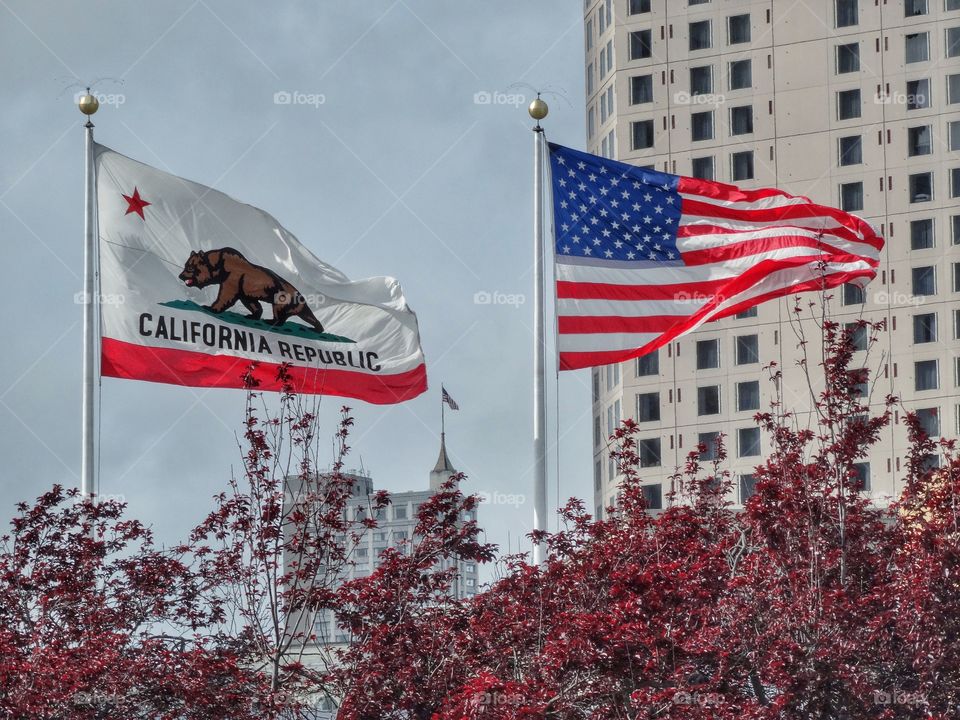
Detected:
left=0, top=0, right=592, bottom=572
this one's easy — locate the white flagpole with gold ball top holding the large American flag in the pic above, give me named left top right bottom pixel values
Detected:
left=527, top=93, right=548, bottom=565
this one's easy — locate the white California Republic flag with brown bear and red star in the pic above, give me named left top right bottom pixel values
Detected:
left=95, top=145, right=427, bottom=403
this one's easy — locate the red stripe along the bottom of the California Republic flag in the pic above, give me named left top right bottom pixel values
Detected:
left=101, top=338, right=427, bottom=405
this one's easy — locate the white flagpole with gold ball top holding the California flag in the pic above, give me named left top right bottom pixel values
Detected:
left=78, top=88, right=100, bottom=498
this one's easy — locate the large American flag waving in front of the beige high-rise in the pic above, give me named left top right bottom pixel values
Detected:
left=549, top=143, right=883, bottom=370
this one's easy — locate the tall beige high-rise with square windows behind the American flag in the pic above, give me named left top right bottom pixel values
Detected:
left=584, top=0, right=960, bottom=514
